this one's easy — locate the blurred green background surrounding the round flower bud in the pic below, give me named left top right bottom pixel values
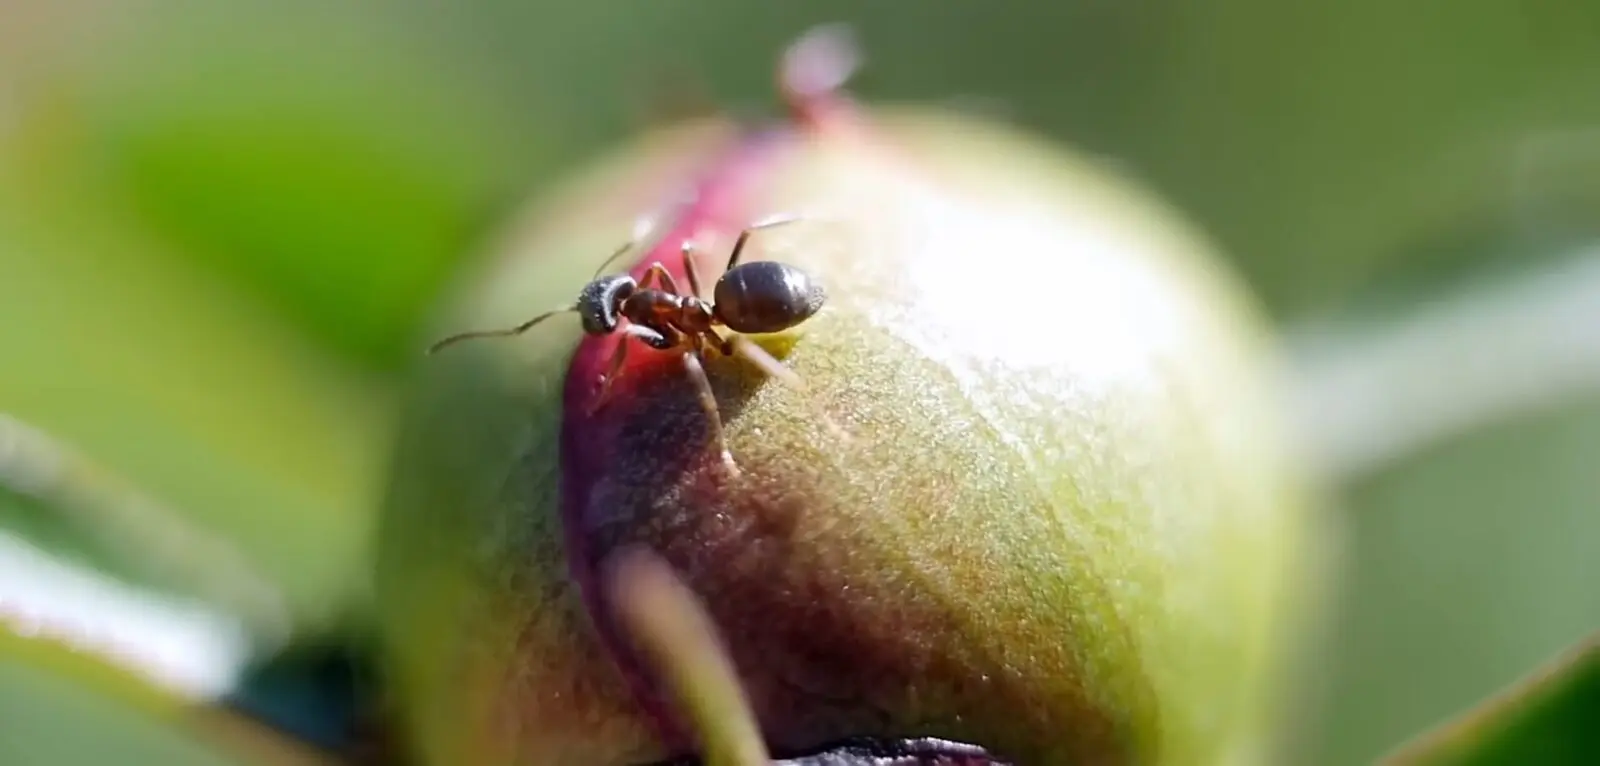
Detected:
left=0, top=0, right=1600, bottom=766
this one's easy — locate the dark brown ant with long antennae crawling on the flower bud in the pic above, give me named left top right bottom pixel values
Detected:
left=429, top=216, right=827, bottom=475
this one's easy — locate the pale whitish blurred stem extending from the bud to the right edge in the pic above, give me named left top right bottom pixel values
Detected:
left=1290, top=246, right=1600, bottom=483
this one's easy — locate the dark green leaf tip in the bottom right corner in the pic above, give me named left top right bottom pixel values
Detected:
left=1386, top=633, right=1600, bottom=766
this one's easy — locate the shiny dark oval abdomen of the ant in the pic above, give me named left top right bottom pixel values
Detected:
left=712, top=261, right=827, bottom=333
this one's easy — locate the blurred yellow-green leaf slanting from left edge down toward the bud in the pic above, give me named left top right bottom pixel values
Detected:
left=0, top=128, right=389, bottom=630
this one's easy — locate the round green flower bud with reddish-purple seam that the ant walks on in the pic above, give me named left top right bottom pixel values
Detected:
left=376, top=23, right=1320, bottom=766
